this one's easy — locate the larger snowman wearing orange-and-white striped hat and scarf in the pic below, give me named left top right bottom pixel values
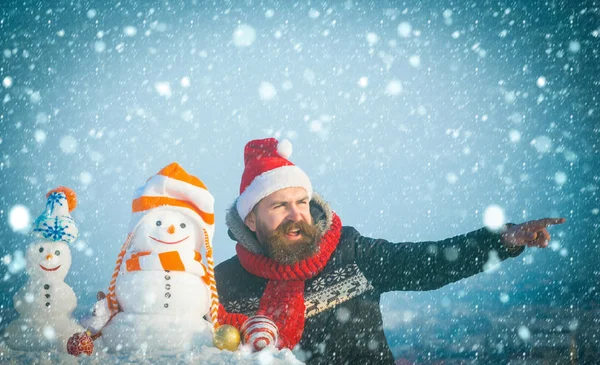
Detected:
left=81, top=163, right=218, bottom=353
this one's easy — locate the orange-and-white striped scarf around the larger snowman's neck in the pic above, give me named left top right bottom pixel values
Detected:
left=124, top=247, right=210, bottom=285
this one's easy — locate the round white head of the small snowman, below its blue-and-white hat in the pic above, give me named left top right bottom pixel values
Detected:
left=27, top=241, right=71, bottom=281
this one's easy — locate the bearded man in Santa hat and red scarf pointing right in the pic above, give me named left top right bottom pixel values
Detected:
left=215, top=138, right=564, bottom=365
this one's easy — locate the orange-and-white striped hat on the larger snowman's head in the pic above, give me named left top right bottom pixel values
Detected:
left=129, top=162, right=215, bottom=242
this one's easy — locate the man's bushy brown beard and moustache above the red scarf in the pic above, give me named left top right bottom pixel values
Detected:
left=256, top=221, right=319, bottom=265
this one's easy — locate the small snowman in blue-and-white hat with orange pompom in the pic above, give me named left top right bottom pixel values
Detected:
left=4, top=187, right=82, bottom=351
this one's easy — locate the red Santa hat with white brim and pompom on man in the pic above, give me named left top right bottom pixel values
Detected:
left=236, top=138, right=312, bottom=220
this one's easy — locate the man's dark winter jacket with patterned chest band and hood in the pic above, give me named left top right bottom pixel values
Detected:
left=215, top=196, right=523, bottom=365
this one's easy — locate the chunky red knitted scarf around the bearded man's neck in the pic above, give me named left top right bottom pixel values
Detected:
left=219, top=213, right=342, bottom=349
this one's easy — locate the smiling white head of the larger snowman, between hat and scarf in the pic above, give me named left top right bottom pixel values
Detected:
left=131, top=207, right=204, bottom=253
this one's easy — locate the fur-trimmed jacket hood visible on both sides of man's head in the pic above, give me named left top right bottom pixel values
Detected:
left=225, top=192, right=333, bottom=255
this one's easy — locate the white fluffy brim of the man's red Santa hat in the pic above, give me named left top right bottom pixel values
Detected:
left=235, top=166, right=312, bottom=221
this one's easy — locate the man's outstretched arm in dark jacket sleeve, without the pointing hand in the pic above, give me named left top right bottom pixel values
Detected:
left=355, top=228, right=524, bottom=292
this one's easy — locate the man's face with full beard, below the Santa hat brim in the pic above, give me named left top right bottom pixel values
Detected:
left=245, top=188, right=318, bottom=265
